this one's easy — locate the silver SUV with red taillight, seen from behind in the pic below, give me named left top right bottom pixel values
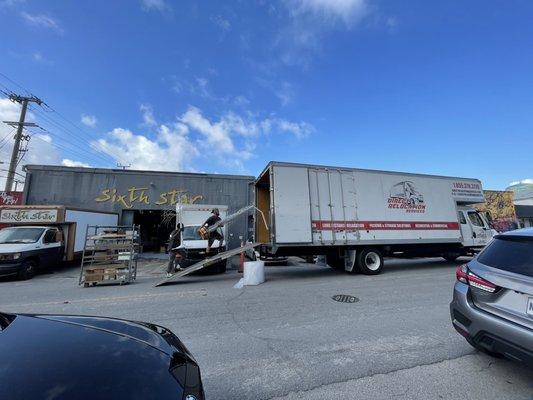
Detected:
left=450, top=228, right=533, bottom=364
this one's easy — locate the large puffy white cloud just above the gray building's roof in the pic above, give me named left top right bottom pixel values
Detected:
left=91, top=107, right=314, bottom=171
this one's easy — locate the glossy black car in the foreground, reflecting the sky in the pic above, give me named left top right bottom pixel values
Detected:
left=0, top=313, right=204, bottom=400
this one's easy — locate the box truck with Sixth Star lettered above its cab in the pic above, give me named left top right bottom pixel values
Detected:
left=0, top=206, right=118, bottom=279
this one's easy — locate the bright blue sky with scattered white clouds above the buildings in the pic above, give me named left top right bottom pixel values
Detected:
left=0, top=0, right=533, bottom=189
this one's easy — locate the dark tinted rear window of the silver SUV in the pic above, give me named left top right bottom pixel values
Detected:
left=478, top=235, right=533, bottom=277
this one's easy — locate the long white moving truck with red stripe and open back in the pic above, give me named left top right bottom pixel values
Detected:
left=255, top=162, right=495, bottom=274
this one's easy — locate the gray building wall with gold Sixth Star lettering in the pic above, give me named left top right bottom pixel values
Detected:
left=24, top=165, right=255, bottom=247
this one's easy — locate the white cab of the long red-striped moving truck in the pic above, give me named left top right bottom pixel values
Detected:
left=457, top=206, right=497, bottom=249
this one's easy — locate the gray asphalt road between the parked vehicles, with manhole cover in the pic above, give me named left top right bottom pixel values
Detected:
left=0, top=259, right=533, bottom=400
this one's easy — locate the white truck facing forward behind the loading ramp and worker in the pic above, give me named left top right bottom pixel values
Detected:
left=175, top=204, right=228, bottom=272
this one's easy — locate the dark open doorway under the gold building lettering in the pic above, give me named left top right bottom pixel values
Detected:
left=133, top=210, right=176, bottom=253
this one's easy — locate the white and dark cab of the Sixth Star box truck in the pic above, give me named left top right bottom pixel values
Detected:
left=0, top=226, right=65, bottom=279
